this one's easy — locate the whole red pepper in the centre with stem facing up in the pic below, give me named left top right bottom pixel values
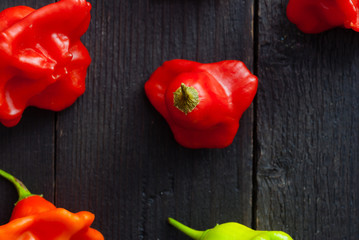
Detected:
left=145, top=59, right=258, bottom=148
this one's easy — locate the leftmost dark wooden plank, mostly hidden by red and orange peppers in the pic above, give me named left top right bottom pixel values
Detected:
left=0, top=0, right=55, bottom=224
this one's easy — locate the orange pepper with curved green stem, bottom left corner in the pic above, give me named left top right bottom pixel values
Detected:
left=0, top=169, right=104, bottom=240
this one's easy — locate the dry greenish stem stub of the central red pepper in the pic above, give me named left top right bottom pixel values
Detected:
left=173, top=83, right=199, bottom=115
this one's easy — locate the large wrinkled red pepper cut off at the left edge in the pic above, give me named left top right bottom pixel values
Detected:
left=0, top=0, right=91, bottom=127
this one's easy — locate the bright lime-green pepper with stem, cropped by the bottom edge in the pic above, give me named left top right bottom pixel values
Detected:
left=168, top=218, right=293, bottom=240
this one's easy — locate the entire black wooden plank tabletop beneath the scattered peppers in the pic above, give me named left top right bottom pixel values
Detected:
left=0, top=0, right=359, bottom=240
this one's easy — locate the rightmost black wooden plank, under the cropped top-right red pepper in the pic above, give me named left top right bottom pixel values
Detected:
left=256, top=0, right=359, bottom=240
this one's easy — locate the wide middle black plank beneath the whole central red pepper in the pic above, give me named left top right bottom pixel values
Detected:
left=56, top=0, right=253, bottom=239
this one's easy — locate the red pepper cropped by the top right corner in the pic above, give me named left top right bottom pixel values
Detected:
left=287, top=0, right=359, bottom=33
